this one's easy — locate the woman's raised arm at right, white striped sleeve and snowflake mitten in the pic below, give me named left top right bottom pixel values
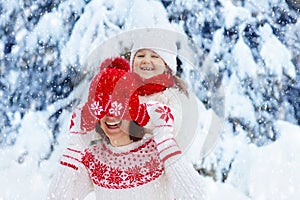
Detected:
left=147, top=102, right=206, bottom=200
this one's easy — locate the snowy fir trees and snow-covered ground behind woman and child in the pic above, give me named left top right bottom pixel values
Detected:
left=0, top=0, right=300, bottom=200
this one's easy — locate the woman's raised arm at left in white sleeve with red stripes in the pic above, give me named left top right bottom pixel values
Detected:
left=47, top=105, right=93, bottom=200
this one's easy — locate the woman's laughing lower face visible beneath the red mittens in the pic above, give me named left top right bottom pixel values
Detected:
left=100, top=116, right=132, bottom=146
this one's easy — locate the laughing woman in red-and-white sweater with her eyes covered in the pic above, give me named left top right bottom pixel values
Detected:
left=48, top=59, right=205, bottom=200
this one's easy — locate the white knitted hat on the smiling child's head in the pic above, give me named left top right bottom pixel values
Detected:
left=130, top=31, right=177, bottom=74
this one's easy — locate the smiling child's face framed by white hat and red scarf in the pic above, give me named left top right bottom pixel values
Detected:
left=133, top=49, right=167, bottom=78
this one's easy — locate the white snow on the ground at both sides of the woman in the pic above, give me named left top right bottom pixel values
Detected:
left=0, top=108, right=300, bottom=200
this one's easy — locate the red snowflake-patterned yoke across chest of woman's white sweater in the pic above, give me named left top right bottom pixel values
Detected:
left=61, top=139, right=164, bottom=189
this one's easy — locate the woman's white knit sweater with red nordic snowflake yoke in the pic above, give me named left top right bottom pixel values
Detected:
left=47, top=102, right=206, bottom=200
